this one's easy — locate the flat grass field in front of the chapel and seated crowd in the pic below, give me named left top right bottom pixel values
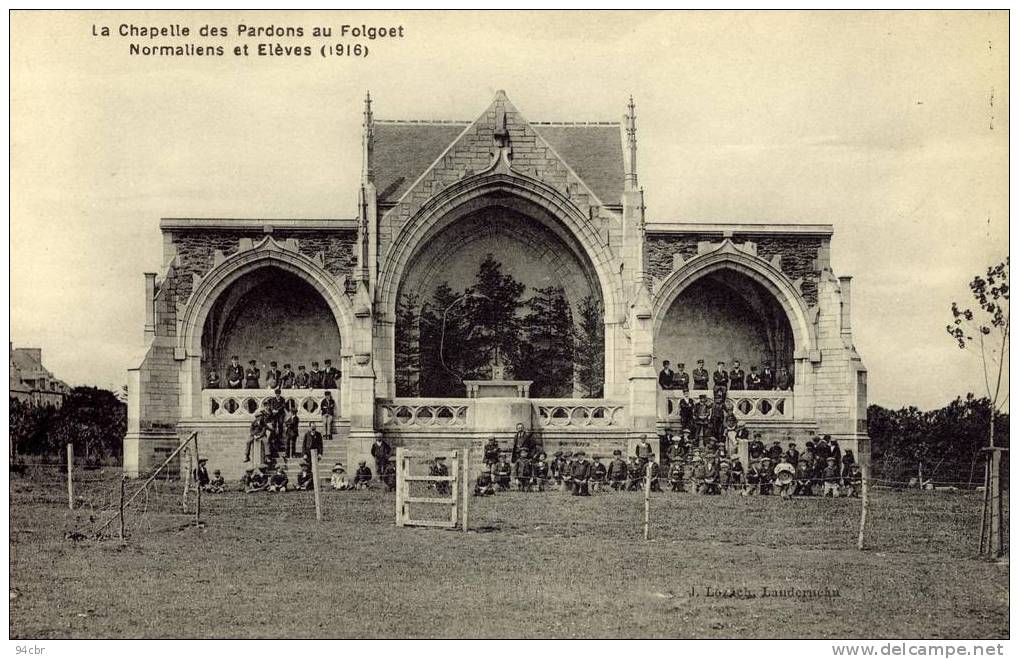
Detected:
left=10, top=473, right=1009, bottom=639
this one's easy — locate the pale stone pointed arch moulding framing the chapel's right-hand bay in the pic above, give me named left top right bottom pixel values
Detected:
left=652, top=240, right=816, bottom=354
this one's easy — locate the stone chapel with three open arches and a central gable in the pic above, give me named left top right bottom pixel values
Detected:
left=124, top=92, right=869, bottom=479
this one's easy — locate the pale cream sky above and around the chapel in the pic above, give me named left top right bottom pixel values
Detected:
left=10, top=11, right=1009, bottom=408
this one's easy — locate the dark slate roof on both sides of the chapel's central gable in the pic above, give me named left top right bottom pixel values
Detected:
left=372, top=121, right=624, bottom=206
